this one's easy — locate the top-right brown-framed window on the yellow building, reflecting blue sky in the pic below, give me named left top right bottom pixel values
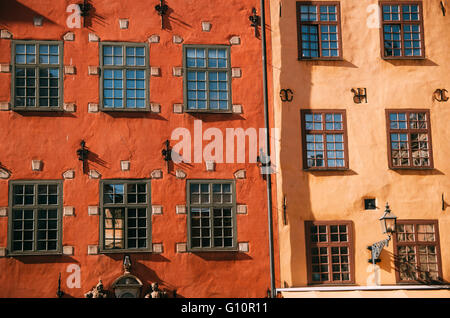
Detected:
left=380, top=2, right=425, bottom=59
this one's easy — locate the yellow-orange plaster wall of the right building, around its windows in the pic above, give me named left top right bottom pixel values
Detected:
left=270, top=0, right=450, bottom=293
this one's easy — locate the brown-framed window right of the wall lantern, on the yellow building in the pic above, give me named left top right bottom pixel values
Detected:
left=394, top=220, right=442, bottom=283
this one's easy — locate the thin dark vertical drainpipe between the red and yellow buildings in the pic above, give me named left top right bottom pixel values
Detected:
left=261, top=0, right=276, bottom=298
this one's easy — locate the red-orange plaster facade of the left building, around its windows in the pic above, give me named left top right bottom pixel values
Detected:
left=0, top=0, right=278, bottom=297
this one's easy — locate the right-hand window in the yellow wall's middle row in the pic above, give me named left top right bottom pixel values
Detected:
left=386, top=110, right=433, bottom=169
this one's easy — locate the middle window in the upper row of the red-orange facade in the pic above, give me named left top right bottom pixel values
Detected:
left=100, top=42, right=149, bottom=111
